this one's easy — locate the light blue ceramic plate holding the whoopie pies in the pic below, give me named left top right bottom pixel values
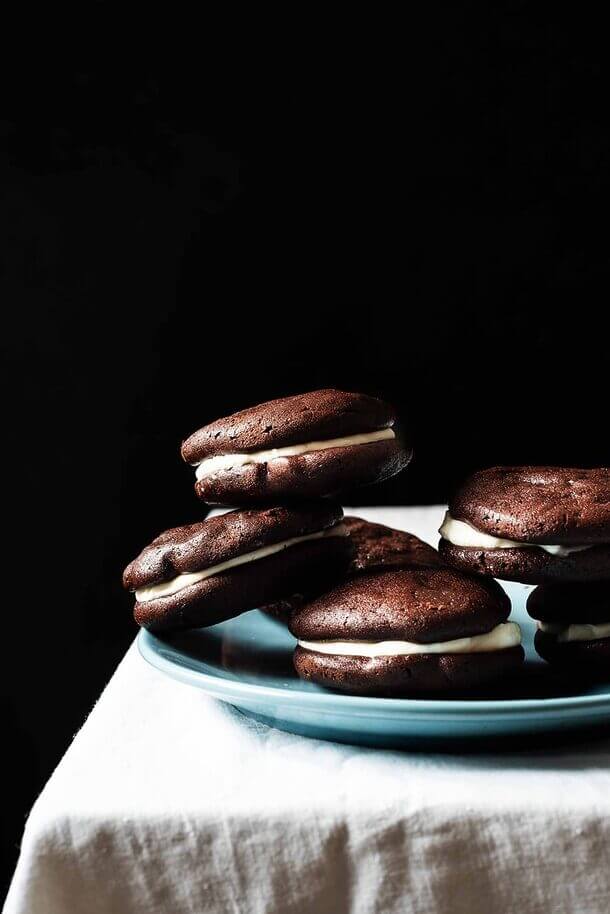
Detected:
left=138, top=584, right=610, bottom=746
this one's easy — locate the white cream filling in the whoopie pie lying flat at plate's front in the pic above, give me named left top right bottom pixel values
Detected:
left=299, top=622, right=521, bottom=657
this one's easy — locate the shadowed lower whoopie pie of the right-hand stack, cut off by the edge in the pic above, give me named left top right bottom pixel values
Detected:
left=527, top=581, right=610, bottom=674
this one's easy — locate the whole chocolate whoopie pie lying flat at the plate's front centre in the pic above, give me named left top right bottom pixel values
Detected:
left=289, top=567, right=524, bottom=695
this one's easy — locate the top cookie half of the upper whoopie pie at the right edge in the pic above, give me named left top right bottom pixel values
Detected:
left=449, top=466, right=610, bottom=545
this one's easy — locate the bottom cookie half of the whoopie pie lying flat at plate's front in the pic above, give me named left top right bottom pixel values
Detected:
left=294, top=645, right=524, bottom=697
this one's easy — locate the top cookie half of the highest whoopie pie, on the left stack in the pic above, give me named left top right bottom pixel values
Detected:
left=182, top=389, right=396, bottom=463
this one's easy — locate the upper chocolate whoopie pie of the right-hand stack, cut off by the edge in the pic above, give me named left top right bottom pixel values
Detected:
left=439, top=467, right=610, bottom=584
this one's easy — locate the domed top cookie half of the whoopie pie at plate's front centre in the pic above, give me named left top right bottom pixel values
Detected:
left=289, top=567, right=510, bottom=644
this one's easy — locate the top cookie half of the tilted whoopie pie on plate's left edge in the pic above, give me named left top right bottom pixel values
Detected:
left=123, top=501, right=343, bottom=590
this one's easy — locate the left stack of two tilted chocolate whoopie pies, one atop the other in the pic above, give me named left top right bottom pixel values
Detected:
left=123, top=390, right=411, bottom=631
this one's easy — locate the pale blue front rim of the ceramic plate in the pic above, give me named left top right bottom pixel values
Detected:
left=136, top=629, right=610, bottom=720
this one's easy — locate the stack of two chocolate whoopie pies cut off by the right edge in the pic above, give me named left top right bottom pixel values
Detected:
left=439, top=466, right=610, bottom=673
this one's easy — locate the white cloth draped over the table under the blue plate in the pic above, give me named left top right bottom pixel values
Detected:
left=5, top=508, right=610, bottom=914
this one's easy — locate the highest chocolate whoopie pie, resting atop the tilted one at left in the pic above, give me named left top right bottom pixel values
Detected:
left=182, top=390, right=412, bottom=505
